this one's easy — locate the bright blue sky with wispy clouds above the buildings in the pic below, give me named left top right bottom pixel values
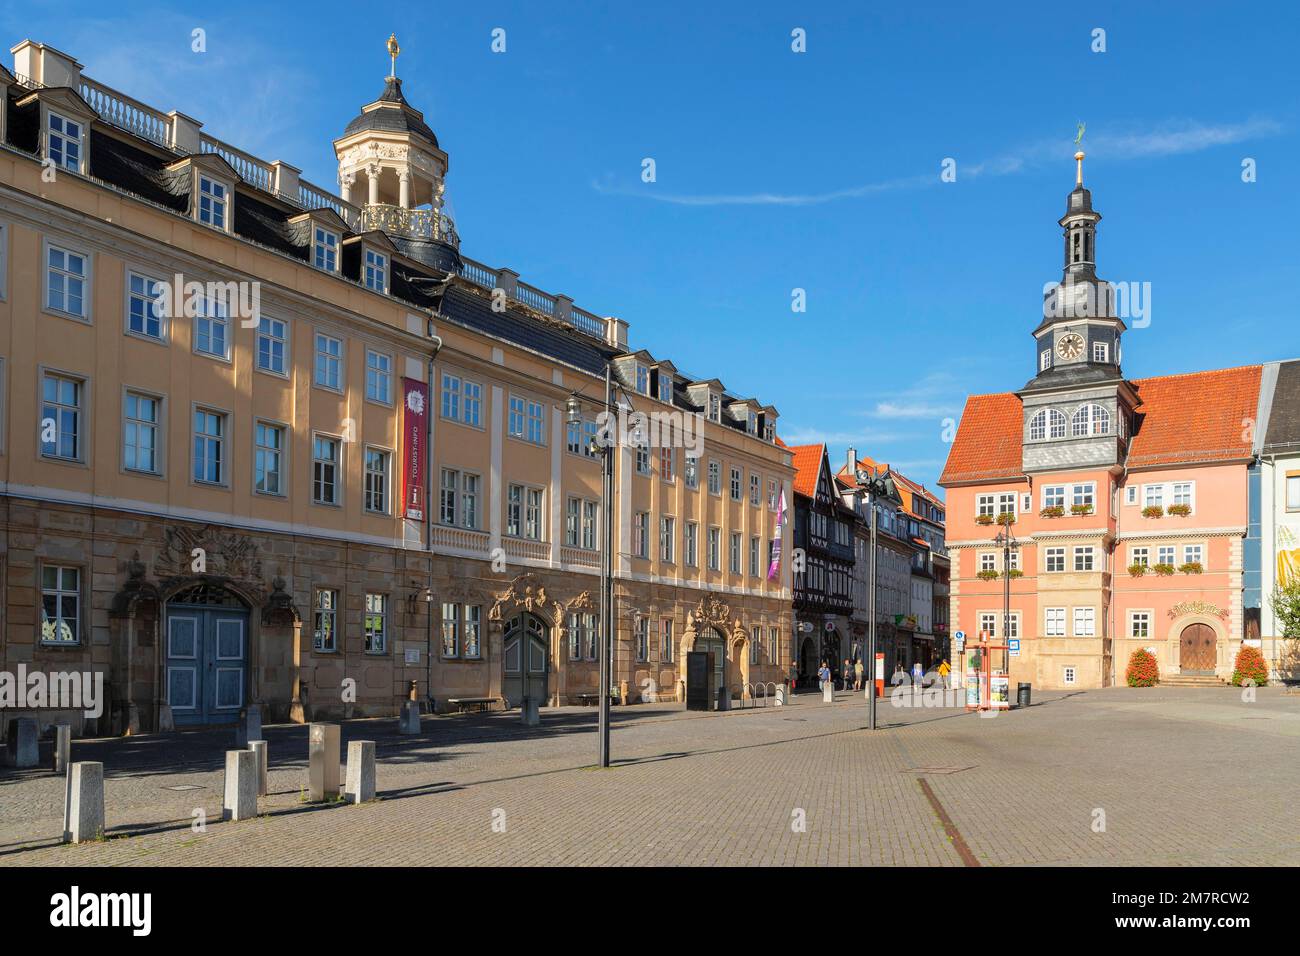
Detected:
left=0, top=0, right=1300, bottom=494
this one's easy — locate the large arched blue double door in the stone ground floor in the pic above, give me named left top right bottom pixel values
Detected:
left=163, top=581, right=248, bottom=727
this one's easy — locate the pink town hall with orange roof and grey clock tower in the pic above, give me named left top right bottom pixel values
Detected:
left=940, top=153, right=1261, bottom=689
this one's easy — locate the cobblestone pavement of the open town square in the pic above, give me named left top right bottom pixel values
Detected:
left=0, top=688, right=1300, bottom=866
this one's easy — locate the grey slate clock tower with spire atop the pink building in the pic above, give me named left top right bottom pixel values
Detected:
left=1018, top=152, right=1138, bottom=473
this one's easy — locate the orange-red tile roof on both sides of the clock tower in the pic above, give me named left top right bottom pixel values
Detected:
left=939, top=365, right=1261, bottom=486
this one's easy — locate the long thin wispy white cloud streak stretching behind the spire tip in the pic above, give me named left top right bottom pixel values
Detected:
left=592, top=117, right=1284, bottom=206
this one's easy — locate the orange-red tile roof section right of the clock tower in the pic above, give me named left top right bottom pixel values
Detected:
left=1128, top=365, right=1264, bottom=468
